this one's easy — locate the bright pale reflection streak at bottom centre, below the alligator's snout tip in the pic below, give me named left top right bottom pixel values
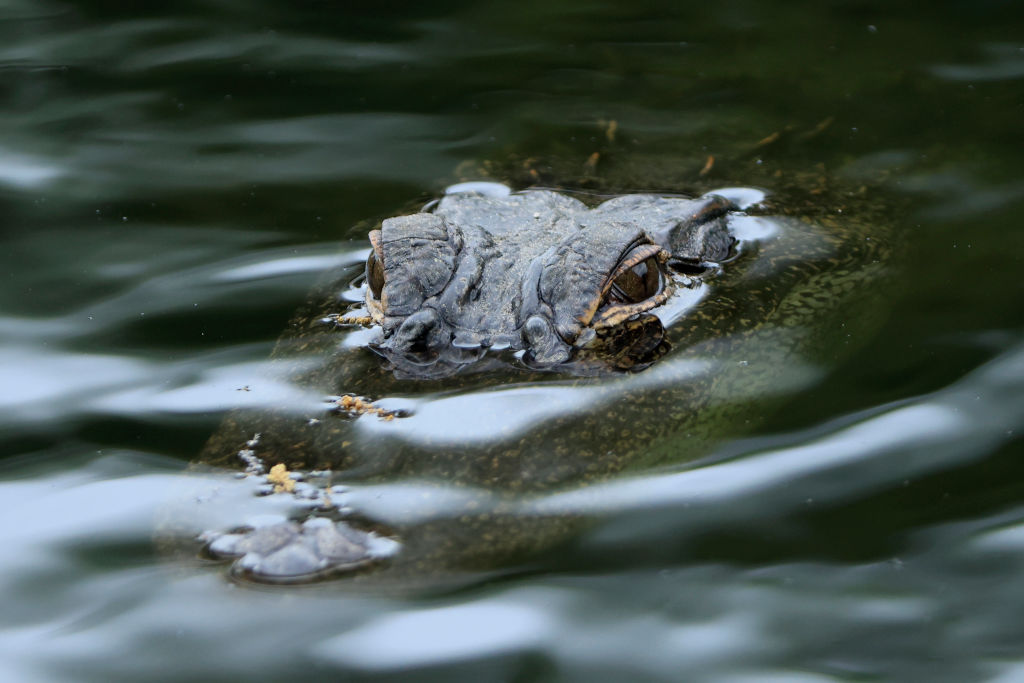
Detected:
left=311, top=588, right=773, bottom=674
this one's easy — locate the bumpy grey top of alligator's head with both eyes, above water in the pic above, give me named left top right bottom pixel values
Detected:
left=366, top=183, right=738, bottom=377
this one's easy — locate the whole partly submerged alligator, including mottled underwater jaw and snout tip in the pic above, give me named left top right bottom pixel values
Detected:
left=165, top=183, right=886, bottom=585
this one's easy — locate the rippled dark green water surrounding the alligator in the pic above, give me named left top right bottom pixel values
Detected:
left=0, top=0, right=1024, bottom=682
